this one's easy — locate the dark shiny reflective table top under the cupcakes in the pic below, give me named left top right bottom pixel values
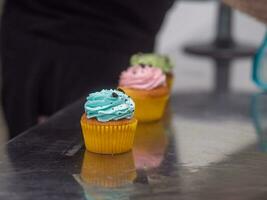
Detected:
left=0, top=93, right=267, bottom=200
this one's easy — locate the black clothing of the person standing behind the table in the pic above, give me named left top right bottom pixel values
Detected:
left=1, top=0, right=172, bottom=137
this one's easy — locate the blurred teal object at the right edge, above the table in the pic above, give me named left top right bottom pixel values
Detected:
left=252, top=32, right=267, bottom=91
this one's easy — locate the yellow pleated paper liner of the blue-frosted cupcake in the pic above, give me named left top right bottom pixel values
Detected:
left=81, top=115, right=137, bottom=154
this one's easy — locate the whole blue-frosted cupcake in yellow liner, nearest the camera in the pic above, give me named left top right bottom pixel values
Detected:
left=81, top=89, right=137, bottom=154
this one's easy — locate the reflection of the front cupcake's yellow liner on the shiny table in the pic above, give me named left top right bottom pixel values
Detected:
left=81, top=151, right=136, bottom=188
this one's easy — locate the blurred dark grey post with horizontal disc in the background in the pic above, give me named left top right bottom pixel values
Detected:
left=184, top=3, right=256, bottom=93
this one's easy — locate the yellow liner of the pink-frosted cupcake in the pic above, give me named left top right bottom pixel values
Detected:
left=131, top=94, right=169, bottom=122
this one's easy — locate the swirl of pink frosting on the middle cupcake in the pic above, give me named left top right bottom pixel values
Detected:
left=119, top=65, right=166, bottom=90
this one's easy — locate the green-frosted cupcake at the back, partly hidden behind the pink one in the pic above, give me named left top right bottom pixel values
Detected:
left=130, top=53, right=173, bottom=89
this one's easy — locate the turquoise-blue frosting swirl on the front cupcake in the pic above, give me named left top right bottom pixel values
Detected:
left=84, top=89, right=135, bottom=122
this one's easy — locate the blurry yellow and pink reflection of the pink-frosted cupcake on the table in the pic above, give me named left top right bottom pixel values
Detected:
left=133, top=121, right=168, bottom=169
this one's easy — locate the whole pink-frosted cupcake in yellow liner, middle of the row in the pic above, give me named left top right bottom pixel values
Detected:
left=119, top=65, right=169, bottom=121
